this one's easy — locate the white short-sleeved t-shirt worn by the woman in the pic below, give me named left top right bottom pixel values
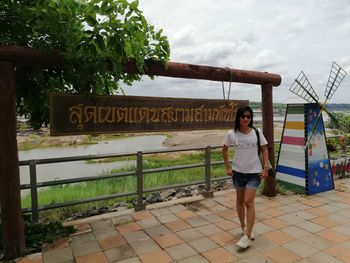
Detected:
left=223, top=129, right=267, bottom=173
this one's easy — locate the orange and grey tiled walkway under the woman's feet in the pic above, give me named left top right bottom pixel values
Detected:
left=20, top=179, right=350, bottom=263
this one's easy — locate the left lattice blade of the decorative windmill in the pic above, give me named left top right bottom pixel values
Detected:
left=289, top=71, right=319, bottom=103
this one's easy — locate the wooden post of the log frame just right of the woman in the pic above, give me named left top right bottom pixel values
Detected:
left=261, top=83, right=276, bottom=196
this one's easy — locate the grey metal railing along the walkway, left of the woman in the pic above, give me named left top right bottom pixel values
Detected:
left=19, top=146, right=229, bottom=222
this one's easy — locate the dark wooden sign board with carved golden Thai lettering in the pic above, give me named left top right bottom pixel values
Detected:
left=50, top=93, right=249, bottom=136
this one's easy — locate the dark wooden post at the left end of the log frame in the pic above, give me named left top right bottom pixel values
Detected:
left=0, top=61, right=25, bottom=260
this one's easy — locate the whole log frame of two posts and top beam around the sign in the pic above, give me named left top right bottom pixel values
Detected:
left=0, top=46, right=281, bottom=259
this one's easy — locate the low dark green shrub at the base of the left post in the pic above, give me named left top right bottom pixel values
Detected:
left=0, top=220, right=75, bottom=254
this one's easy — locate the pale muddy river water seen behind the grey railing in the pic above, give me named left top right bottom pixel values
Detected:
left=19, top=135, right=166, bottom=184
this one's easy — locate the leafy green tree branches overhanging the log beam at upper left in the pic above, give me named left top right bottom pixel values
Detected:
left=0, top=0, right=170, bottom=128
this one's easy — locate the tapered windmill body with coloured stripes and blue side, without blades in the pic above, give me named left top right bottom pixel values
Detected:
left=276, top=103, right=334, bottom=194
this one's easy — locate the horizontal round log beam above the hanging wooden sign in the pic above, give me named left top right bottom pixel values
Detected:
left=0, top=46, right=282, bottom=86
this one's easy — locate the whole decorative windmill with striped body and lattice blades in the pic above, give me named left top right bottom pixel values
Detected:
left=276, top=62, right=346, bottom=194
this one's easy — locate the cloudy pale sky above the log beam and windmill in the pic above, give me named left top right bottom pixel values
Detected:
left=125, top=0, right=350, bottom=103
